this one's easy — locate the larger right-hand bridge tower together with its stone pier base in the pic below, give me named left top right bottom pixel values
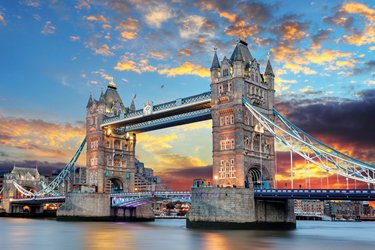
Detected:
left=186, top=39, right=296, bottom=230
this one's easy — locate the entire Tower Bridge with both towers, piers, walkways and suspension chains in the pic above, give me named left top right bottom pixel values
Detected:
left=1, top=37, right=375, bottom=229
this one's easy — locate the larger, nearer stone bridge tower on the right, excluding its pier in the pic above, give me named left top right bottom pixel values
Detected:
left=211, top=39, right=275, bottom=187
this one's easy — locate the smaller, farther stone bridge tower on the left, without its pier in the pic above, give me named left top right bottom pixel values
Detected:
left=86, top=82, right=136, bottom=193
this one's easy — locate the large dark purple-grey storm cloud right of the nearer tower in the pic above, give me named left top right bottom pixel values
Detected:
left=277, top=89, right=375, bottom=154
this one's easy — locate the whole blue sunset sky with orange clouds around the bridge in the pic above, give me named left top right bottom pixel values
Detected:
left=0, top=0, right=375, bottom=189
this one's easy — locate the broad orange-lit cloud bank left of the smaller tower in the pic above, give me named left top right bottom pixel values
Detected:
left=0, top=116, right=85, bottom=162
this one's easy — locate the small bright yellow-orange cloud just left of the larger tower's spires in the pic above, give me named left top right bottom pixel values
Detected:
left=158, top=62, right=210, bottom=77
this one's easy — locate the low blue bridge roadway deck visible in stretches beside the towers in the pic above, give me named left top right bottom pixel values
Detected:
left=11, top=189, right=375, bottom=206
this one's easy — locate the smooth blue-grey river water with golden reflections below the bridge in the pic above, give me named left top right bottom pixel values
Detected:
left=0, top=218, right=375, bottom=250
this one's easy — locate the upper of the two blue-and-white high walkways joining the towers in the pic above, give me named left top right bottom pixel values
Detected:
left=101, top=92, right=211, bottom=128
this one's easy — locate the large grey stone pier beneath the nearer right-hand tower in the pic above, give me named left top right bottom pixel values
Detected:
left=186, top=187, right=296, bottom=230
